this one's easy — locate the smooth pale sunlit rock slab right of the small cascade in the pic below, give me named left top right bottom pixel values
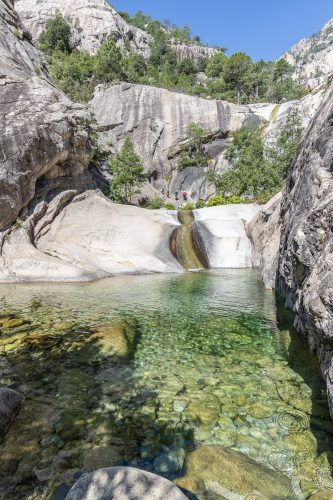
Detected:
left=193, top=204, right=259, bottom=268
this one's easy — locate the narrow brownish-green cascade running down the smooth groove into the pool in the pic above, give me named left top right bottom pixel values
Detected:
left=170, top=210, right=208, bottom=271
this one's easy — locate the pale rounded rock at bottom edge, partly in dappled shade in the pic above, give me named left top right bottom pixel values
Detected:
left=65, top=467, right=186, bottom=500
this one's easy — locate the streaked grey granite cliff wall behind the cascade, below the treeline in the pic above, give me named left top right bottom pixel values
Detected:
left=91, top=83, right=269, bottom=201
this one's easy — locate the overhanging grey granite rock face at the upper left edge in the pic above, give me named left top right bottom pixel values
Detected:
left=0, top=0, right=90, bottom=230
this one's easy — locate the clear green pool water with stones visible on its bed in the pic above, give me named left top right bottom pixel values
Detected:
left=0, top=270, right=333, bottom=499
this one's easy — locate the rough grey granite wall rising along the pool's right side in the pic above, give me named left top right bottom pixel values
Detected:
left=248, top=85, right=333, bottom=417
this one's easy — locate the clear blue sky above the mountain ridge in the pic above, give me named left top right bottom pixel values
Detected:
left=110, top=0, right=333, bottom=60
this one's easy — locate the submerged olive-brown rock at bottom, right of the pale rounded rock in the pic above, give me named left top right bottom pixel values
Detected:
left=181, top=445, right=295, bottom=500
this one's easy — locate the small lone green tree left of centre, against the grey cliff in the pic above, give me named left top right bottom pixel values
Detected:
left=108, top=136, right=148, bottom=204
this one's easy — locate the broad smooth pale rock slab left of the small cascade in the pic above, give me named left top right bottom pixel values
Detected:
left=0, top=191, right=182, bottom=282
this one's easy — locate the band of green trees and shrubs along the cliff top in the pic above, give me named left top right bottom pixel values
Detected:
left=39, top=12, right=307, bottom=104
